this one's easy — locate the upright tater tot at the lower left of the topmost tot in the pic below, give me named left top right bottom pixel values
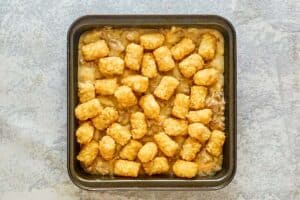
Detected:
left=124, top=43, right=144, bottom=70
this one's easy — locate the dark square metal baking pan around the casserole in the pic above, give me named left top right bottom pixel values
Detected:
left=67, top=15, right=237, bottom=190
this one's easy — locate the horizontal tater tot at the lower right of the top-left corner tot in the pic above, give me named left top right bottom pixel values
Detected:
left=98, top=56, right=124, bottom=76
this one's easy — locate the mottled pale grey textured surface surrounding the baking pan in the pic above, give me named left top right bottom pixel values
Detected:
left=0, top=0, right=300, bottom=200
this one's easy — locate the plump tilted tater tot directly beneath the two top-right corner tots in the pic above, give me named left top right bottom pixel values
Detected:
left=178, top=53, right=204, bottom=78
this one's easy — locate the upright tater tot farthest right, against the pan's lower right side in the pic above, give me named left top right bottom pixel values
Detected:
left=206, top=130, right=225, bottom=156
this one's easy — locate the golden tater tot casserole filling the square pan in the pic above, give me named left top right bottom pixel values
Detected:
left=75, top=27, right=226, bottom=178
